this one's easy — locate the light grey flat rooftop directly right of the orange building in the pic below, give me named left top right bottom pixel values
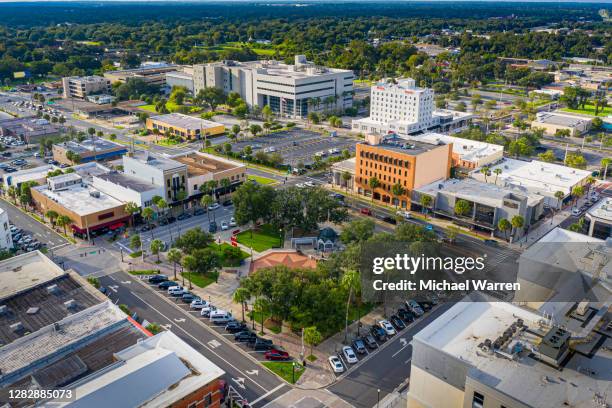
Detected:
left=415, top=178, right=543, bottom=207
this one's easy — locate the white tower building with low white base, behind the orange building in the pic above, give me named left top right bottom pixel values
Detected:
left=352, top=78, right=472, bottom=136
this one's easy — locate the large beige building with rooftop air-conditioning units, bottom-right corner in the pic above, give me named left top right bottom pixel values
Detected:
left=407, top=301, right=612, bottom=408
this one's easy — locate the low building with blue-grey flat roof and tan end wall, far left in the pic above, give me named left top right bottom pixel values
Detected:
left=52, top=138, right=127, bottom=165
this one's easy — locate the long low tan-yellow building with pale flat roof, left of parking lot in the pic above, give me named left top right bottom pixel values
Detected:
left=146, top=113, right=225, bottom=139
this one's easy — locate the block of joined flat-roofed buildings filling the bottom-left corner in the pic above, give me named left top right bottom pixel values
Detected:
left=0, top=251, right=225, bottom=408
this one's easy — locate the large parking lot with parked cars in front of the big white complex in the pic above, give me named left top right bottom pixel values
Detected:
left=232, top=129, right=356, bottom=166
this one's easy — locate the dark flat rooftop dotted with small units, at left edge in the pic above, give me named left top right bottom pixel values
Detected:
left=0, top=272, right=104, bottom=347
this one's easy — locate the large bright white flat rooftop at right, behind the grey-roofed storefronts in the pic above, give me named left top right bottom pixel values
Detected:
left=471, top=158, right=591, bottom=195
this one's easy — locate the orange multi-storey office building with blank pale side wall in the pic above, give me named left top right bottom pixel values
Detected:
left=355, top=135, right=452, bottom=208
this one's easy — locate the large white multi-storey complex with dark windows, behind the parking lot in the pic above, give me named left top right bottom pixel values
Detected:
left=191, top=55, right=354, bottom=118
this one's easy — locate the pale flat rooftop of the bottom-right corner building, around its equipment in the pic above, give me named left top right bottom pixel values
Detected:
left=414, top=302, right=612, bottom=408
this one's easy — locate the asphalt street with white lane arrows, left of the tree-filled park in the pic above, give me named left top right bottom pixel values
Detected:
left=100, top=272, right=290, bottom=408
